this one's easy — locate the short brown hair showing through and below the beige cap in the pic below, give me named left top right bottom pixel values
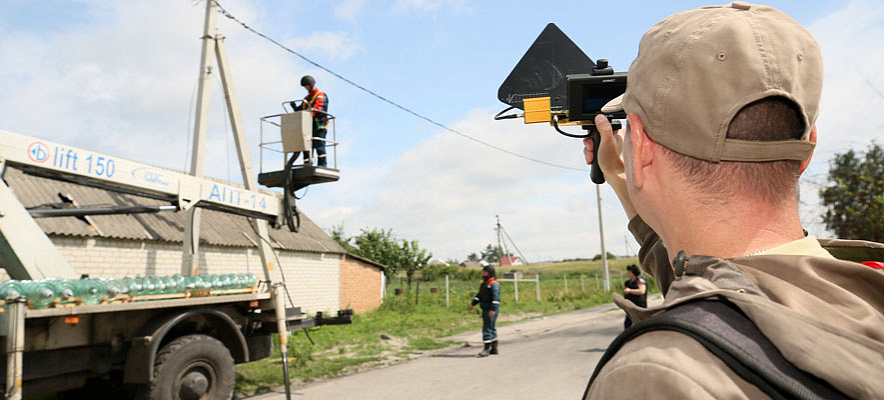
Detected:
left=661, top=96, right=805, bottom=204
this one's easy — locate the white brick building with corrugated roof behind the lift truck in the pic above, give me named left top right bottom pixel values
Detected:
left=0, top=167, right=384, bottom=313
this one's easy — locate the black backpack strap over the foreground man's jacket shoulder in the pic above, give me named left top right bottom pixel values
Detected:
left=583, top=300, right=848, bottom=399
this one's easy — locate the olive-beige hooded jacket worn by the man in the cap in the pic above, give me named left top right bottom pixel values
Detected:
left=586, top=217, right=884, bottom=399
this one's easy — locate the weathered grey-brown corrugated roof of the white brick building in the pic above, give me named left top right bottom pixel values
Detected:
left=3, top=167, right=344, bottom=254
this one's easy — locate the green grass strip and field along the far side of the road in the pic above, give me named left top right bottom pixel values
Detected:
left=236, top=258, right=657, bottom=395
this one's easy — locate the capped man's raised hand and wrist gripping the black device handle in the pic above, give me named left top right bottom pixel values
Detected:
left=583, top=114, right=636, bottom=219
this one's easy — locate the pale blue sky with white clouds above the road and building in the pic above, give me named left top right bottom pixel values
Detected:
left=0, top=0, right=884, bottom=262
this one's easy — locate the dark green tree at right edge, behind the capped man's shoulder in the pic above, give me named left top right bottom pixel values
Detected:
left=820, top=141, right=884, bottom=243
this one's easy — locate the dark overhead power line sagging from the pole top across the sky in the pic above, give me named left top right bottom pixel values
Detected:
left=212, top=0, right=586, bottom=172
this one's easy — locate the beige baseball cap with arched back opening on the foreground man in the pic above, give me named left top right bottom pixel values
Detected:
left=602, top=2, right=823, bottom=162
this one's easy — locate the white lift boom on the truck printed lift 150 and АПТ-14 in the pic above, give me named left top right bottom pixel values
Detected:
left=0, top=130, right=282, bottom=279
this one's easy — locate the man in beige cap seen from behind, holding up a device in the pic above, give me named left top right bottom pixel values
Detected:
left=584, top=2, right=884, bottom=399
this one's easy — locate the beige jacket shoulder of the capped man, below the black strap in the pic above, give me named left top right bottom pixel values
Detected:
left=586, top=331, right=769, bottom=399
